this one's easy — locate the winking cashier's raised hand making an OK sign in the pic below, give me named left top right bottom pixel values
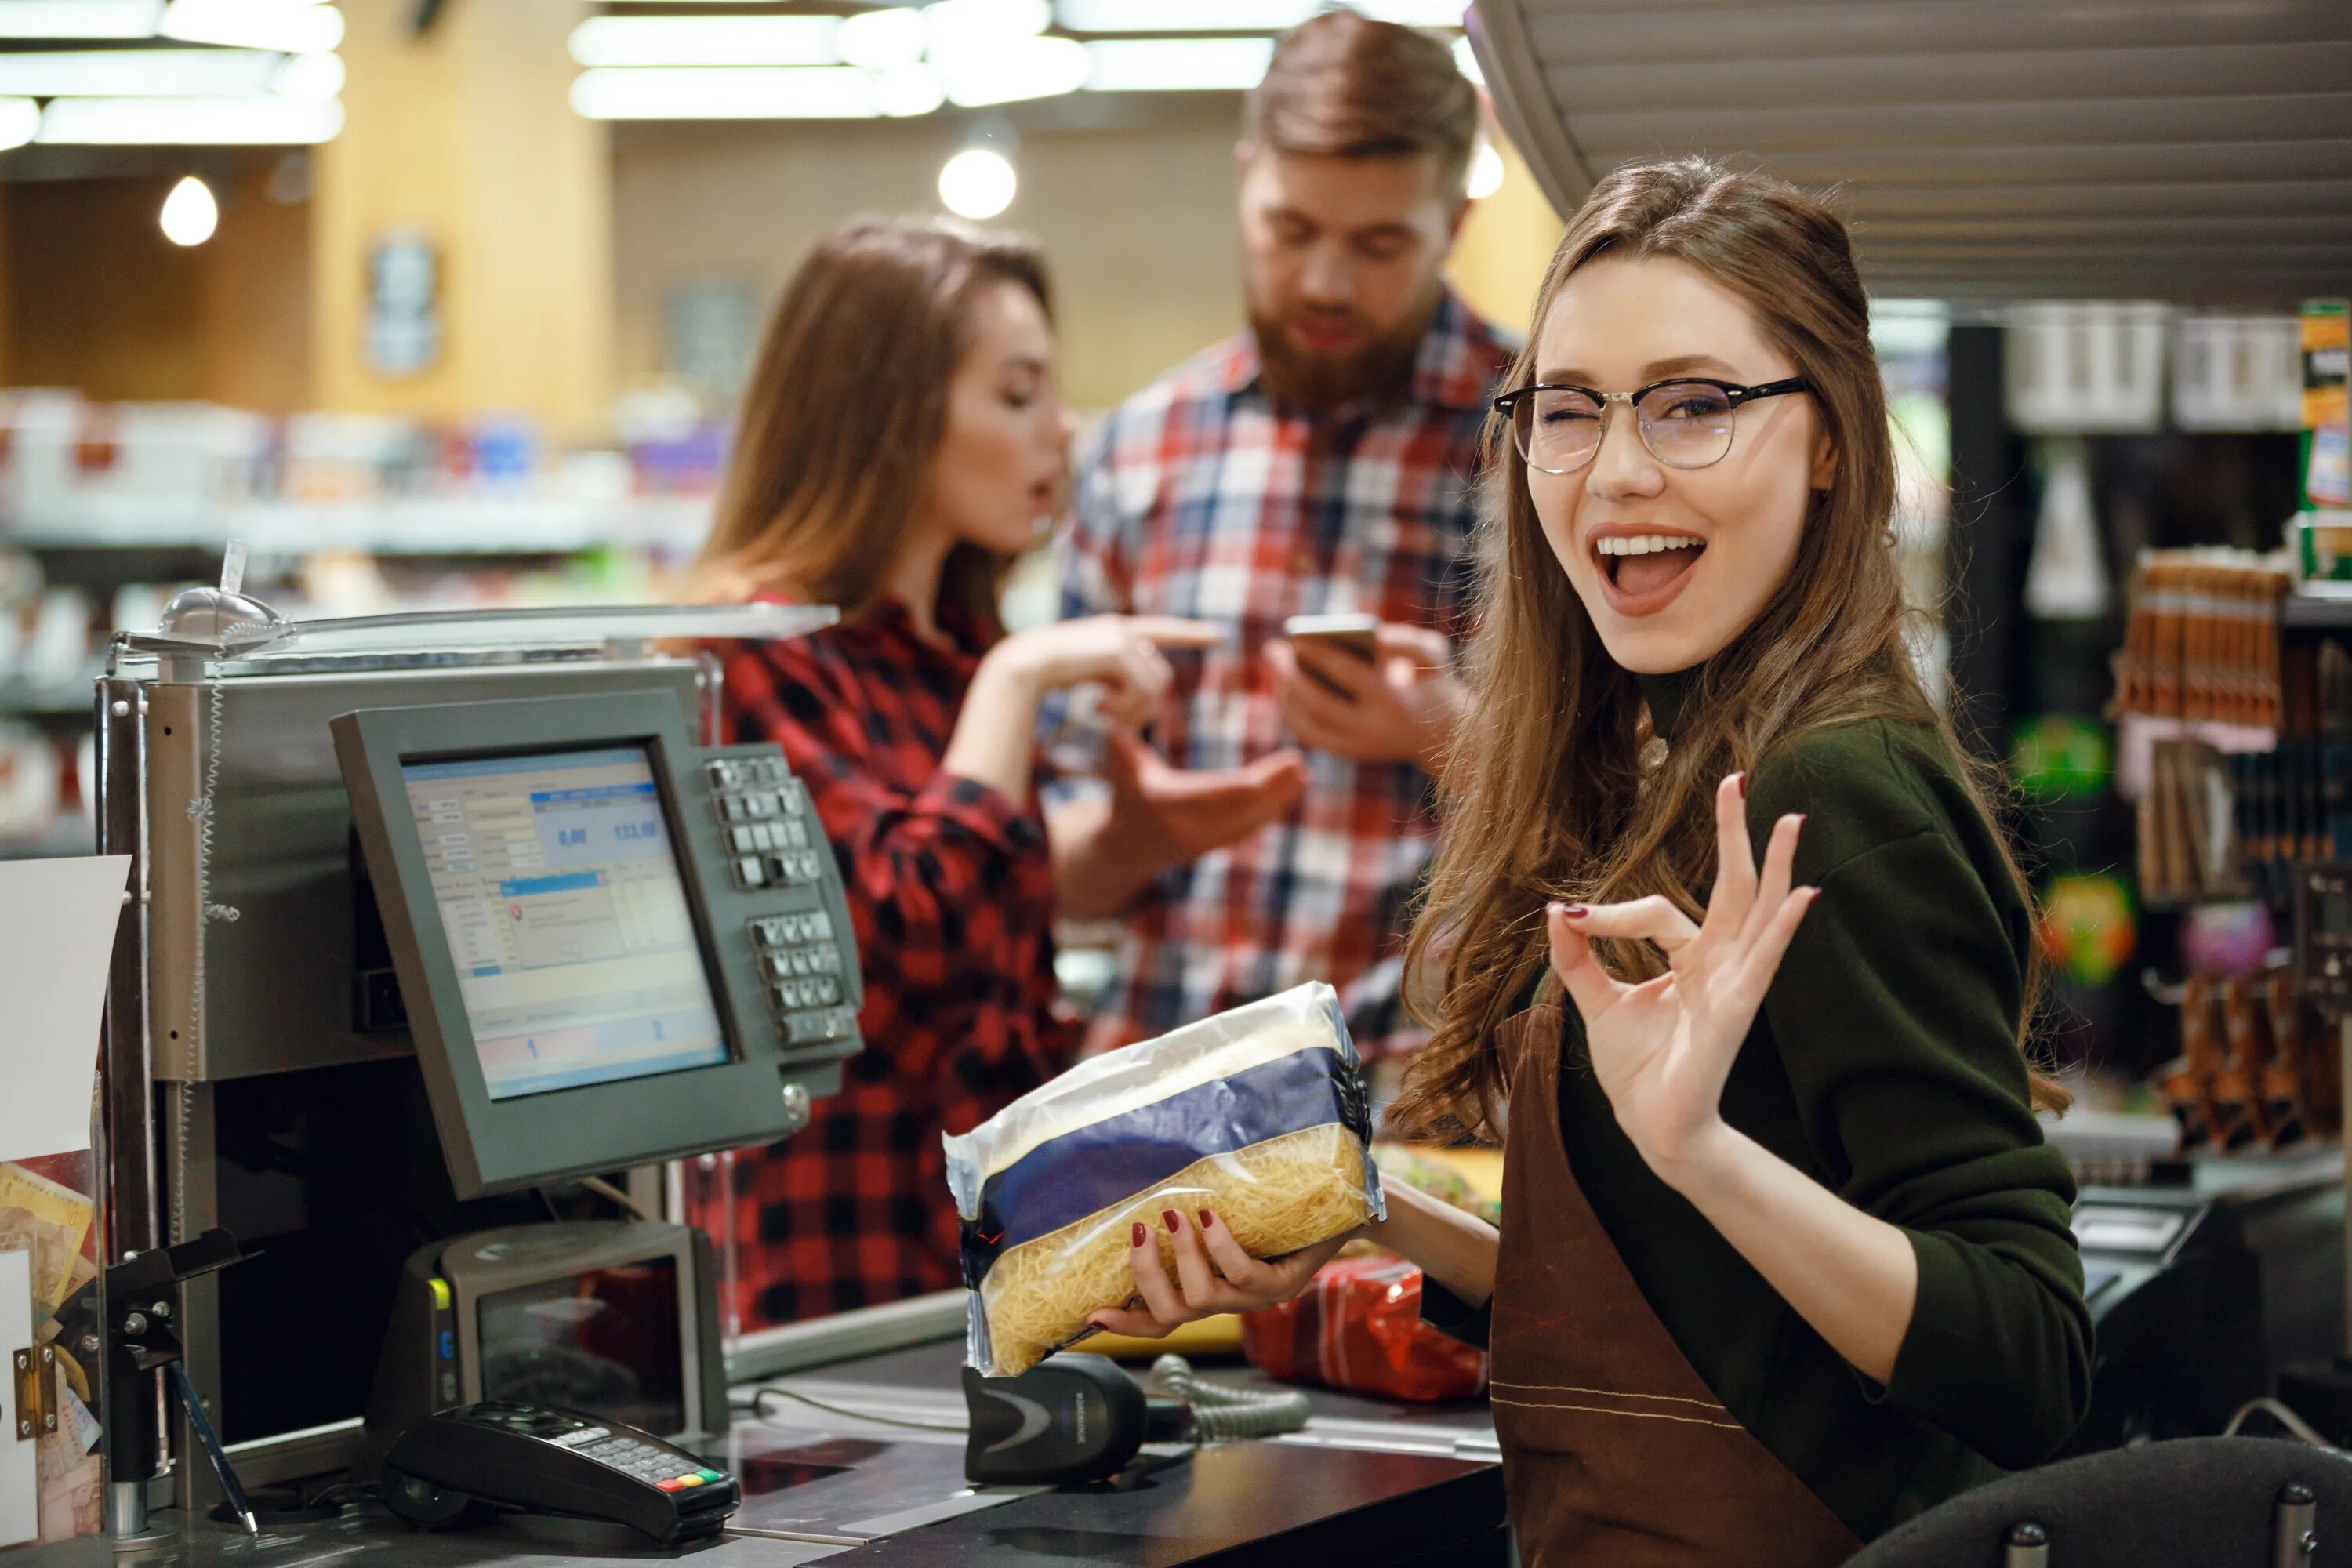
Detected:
left=1548, top=774, right=1820, bottom=1185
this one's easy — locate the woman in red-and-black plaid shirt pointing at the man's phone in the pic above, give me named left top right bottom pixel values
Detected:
left=696, top=219, right=1303, bottom=1326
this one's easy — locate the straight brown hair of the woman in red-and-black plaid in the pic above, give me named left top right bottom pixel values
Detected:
left=691, top=219, right=1051, bottom=633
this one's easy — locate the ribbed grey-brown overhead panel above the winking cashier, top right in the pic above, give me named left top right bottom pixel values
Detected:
left=1475, top=0, right=2352, bottom=303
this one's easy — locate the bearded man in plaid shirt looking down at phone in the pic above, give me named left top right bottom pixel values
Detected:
left=1042, top=9, right=1510, bottom=1079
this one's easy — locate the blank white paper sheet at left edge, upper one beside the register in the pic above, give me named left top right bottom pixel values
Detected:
left=0, top=855, right=132, bottom=1159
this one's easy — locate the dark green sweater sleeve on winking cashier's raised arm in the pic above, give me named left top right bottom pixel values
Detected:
left=1764, top=822, right=2091, bottom=1469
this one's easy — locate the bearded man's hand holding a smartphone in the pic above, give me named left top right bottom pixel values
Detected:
left=1265, top=621, right=1463, bottom=774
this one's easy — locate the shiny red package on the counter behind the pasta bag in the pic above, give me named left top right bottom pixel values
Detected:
left=1242, top=1253, right=1486, bottom=1399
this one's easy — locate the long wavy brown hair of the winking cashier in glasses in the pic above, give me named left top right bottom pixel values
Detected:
left=1388, top=158, right=2067, bottom=1138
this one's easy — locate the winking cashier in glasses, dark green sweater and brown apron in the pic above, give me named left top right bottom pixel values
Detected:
left=1096, top=160, right=2091, bottom=1568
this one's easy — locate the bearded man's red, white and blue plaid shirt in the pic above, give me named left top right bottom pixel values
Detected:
left=1044, top=294, right=1510, bottom=1055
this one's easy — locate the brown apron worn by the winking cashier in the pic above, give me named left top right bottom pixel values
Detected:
left=1489, top=1004, right=1863, bottom=1568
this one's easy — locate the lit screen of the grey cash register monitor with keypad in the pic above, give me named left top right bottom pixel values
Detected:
left=400, top=746, right=727, bottom=1100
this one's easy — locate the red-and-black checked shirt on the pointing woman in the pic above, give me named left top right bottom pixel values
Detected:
left=691, top=602, right=1077, bottom=1328
